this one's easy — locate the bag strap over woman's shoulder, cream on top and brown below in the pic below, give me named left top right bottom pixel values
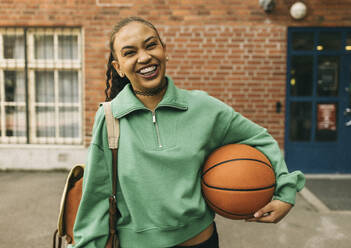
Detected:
left=102, top=102, right=119, bottom=247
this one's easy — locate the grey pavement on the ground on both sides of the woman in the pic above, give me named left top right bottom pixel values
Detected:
left=0, top=171, right=351, bottom=248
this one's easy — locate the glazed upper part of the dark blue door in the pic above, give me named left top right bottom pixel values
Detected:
left=287, top=28, right=351, bottom=143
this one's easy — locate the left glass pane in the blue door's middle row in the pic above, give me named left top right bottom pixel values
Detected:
left=290, top=56, right=313, bottom=96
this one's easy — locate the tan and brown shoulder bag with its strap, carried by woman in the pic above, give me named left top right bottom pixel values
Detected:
left=53, top=102, right=119, bottom=248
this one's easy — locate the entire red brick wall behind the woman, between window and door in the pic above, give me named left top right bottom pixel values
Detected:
left=0, top=0, right=351, bottom=147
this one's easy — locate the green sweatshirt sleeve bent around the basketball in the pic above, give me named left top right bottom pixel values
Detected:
left=222, top=109, right=305, bottom=205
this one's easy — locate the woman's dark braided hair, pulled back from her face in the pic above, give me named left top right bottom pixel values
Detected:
left=105, top=16, right=164, bottom=101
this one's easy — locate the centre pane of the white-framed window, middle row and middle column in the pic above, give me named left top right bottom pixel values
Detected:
left=35, top=71, right=55, bottom=102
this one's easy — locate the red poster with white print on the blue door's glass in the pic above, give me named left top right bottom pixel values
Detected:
left=317, top=104, right=336, bottom=131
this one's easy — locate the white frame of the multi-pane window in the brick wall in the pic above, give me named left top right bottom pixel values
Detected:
left=0, top=28, right=83, bottom=145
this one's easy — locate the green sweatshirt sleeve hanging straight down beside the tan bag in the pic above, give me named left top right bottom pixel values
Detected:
left=71, top=108, right=111, bottom=248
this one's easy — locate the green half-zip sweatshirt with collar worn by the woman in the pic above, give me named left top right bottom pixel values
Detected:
left=74, top=77, right=305, bottom=248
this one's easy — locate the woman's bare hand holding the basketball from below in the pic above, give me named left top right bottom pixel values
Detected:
left=246, top=200, right=293, bottom=223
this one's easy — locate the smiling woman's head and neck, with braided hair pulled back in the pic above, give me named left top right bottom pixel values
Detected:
left=106, top=17, right=167, bottom=109
